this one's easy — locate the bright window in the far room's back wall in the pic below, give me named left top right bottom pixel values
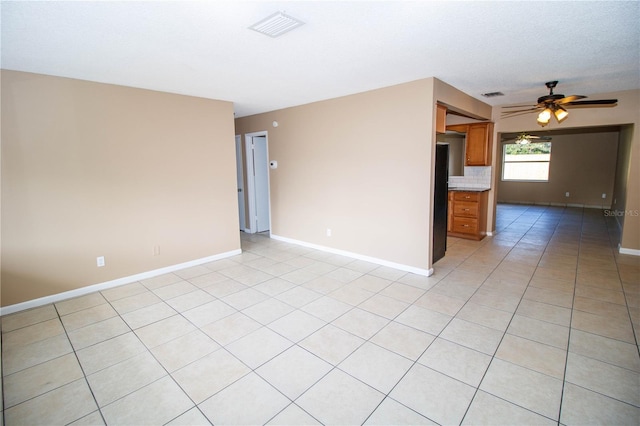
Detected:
left=502, top=142, right=551, bottom=182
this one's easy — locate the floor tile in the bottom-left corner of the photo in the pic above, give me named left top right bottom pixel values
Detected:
left=4, top=379, right=98, bottom=425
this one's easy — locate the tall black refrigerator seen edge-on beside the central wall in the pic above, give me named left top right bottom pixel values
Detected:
left=432, top=143, right=449, bottom=263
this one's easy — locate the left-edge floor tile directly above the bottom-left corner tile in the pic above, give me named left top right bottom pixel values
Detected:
left=3, top=354, right=84, bottom=408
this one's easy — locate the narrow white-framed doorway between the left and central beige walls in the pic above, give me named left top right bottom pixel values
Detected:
left=245, top=132, right=271, bottom=234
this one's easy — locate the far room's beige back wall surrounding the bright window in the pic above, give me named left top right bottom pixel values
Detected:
left=497, top=129, right=618, bottom=208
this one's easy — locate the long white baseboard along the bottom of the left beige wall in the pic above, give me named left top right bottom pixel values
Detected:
left=0, top=249, right=242, bottom=316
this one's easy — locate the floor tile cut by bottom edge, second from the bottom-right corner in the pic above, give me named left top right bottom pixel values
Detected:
left=462, top=391, right=557, bottom=426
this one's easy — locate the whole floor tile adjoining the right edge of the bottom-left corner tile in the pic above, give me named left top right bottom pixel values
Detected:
left=87, top=352, right=167, bottom=407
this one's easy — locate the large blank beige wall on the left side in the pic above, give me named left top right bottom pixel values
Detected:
left=1, top=71, right=240, bottom=306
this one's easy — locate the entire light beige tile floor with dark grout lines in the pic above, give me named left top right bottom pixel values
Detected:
left=0, top=205, right=640, bottom=425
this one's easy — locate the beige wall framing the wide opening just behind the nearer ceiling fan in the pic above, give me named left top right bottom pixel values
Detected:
left=490, top=90, right=640, bottom=250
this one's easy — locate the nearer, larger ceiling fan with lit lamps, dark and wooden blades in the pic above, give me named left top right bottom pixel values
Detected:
left=502, top=81, right=618, bottom=127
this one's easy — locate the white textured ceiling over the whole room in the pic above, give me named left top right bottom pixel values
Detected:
left=0, top=0, right=640, bottom=117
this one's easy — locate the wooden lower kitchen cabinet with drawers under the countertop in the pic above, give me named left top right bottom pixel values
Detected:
left=447, top=191, right=488, bottom=240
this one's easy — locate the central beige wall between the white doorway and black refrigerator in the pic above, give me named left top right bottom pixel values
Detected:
left=236, top=79, right=435, bottom=269
